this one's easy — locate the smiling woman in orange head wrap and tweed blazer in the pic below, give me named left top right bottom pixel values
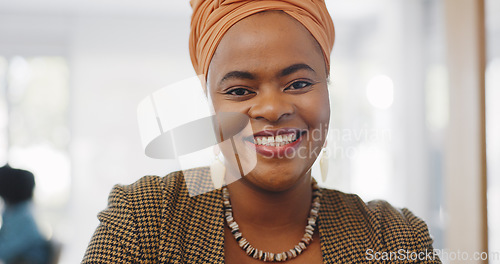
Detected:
left=83, top=0, right=439, bottom=263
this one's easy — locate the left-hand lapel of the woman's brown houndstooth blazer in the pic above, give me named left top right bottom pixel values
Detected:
left=159, top=167, right=224, bottom=264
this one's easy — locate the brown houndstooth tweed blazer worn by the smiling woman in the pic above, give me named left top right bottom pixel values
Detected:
left=82, top=167, right=440, bottom=264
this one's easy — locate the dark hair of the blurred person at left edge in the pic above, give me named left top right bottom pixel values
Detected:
left=0, top=165, right=35, bottom=204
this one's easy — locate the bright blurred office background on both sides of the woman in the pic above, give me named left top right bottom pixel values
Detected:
left=0, top=0, right=500, bottom=264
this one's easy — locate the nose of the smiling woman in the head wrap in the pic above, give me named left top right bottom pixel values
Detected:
left=248, top=89, right=295, bottom=123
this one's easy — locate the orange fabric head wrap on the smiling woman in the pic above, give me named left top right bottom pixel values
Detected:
left=189, top=0, right=335, bottom=80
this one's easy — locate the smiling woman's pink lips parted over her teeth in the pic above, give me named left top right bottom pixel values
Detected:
left=244, top=128, right=307, bottom=158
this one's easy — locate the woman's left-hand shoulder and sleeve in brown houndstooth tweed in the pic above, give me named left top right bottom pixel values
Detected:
left=82, top=168, right=209, bottom=263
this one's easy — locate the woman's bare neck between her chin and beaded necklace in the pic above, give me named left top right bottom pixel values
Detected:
left=228, top=172, right=312, bottom=231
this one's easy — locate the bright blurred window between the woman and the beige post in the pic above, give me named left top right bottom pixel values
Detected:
left=324, top=0, right=448, bottom=248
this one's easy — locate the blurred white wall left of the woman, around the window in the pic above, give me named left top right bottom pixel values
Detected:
left=0, top=4, right=199, bottom=263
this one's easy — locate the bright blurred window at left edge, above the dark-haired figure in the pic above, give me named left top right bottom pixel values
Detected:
left=0, top=56, right=71, bottom=239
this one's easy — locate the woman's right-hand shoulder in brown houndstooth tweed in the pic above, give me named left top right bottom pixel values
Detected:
left=322, top=189, right=432, bottom=251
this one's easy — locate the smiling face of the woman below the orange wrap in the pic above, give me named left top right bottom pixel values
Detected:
left=207, top=11, right=330, bottom=191
